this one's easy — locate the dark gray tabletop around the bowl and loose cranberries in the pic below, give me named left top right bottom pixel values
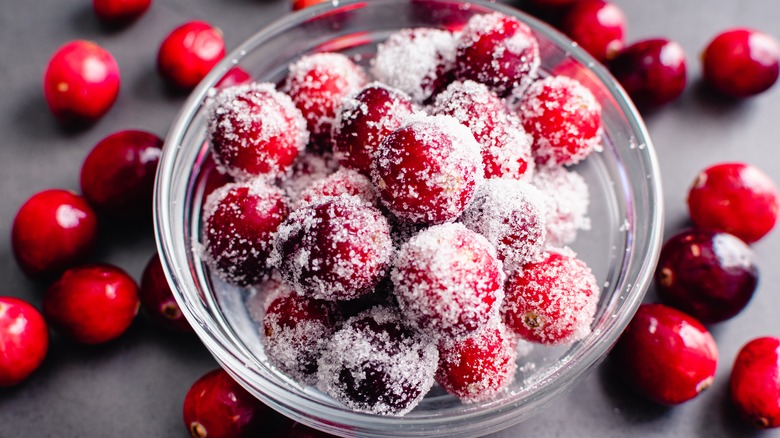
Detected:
left=0, top=0, right=780, bottom=437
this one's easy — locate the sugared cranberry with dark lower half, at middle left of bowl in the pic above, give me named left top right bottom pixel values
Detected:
left=203, top=180, right=290, bottom=286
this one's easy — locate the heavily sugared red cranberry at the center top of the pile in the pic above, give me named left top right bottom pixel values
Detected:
left=371, top=116, right=483, bottom=224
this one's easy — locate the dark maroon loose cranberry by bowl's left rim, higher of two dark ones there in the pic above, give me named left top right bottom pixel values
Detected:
left=81, top=130, right=163, bottom=219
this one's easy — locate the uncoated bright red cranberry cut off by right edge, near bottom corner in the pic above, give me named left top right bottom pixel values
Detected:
left=731, top=337, right=780, bottom=429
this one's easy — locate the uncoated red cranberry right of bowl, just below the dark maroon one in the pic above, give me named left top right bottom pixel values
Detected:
left=612, top=304, right=718, bottom=405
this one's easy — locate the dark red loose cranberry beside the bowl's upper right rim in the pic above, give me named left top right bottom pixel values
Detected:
left=609, top=38, right=687, bottom=107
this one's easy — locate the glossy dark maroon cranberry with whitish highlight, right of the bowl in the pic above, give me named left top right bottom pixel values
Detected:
left=655, top=229, right=758, bottom=324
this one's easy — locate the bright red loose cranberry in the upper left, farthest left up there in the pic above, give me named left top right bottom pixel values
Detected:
left=43, top=40, right=120, bottom=125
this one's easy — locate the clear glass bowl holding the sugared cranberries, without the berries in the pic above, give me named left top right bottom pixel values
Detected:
left=155, top=0, right=663, bottom=437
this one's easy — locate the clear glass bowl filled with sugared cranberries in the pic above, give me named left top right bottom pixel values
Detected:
left=154, top=0, right=663, bottom=437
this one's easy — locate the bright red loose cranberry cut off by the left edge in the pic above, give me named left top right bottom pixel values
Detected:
left=0, top=297, right=49, bottom=387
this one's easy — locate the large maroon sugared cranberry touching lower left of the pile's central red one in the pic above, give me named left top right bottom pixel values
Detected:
left=273, top=195, right=393, bottom=300
